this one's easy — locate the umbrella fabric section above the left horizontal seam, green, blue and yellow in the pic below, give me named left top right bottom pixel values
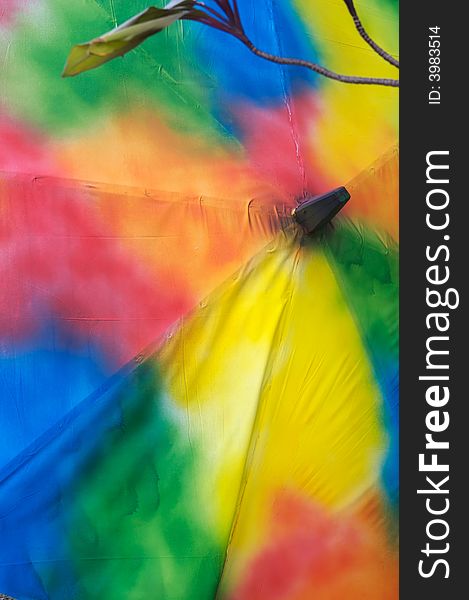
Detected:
left=0, top=0, right=398, bottom=198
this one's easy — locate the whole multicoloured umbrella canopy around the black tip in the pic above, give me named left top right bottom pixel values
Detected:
left=0, top=0, right=397, bottom=600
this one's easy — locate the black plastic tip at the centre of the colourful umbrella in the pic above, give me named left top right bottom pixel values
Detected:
left=292, top=186, right=350, bottom=235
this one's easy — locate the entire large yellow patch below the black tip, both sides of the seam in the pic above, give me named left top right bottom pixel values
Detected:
left=158, top=235, right=386, bottom=585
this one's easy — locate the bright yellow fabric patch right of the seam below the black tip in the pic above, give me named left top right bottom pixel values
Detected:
left=218, top=240, right=386, bottom=586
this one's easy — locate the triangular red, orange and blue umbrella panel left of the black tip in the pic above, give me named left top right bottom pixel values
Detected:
left=0, top=174, right=284, bottom=464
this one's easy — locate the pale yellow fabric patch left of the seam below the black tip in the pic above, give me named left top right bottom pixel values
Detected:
left=158, top=236, right=296, bottom=536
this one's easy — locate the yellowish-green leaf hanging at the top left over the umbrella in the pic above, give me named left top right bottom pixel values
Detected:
left=62, top=0, right=193, bottom=77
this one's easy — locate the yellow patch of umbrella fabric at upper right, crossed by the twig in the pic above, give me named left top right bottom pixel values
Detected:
left=294, top=0, right=399, bottom=185
